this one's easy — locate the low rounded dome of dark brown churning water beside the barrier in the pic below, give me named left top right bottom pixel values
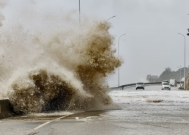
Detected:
left=9, top=68, right=92, bottom=113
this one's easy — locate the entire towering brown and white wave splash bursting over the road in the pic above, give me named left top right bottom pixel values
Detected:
left=0, top=0, right=121, bottom=113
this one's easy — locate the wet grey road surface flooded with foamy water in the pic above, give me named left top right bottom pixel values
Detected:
left=0, top=86, right=189, bottom=135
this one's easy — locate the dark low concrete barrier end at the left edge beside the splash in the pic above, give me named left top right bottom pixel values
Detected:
left=0, top=99, right=13, bottom=119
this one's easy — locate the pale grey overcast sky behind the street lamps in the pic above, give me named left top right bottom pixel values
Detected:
left=5, top=0, right=189, bottom=86
